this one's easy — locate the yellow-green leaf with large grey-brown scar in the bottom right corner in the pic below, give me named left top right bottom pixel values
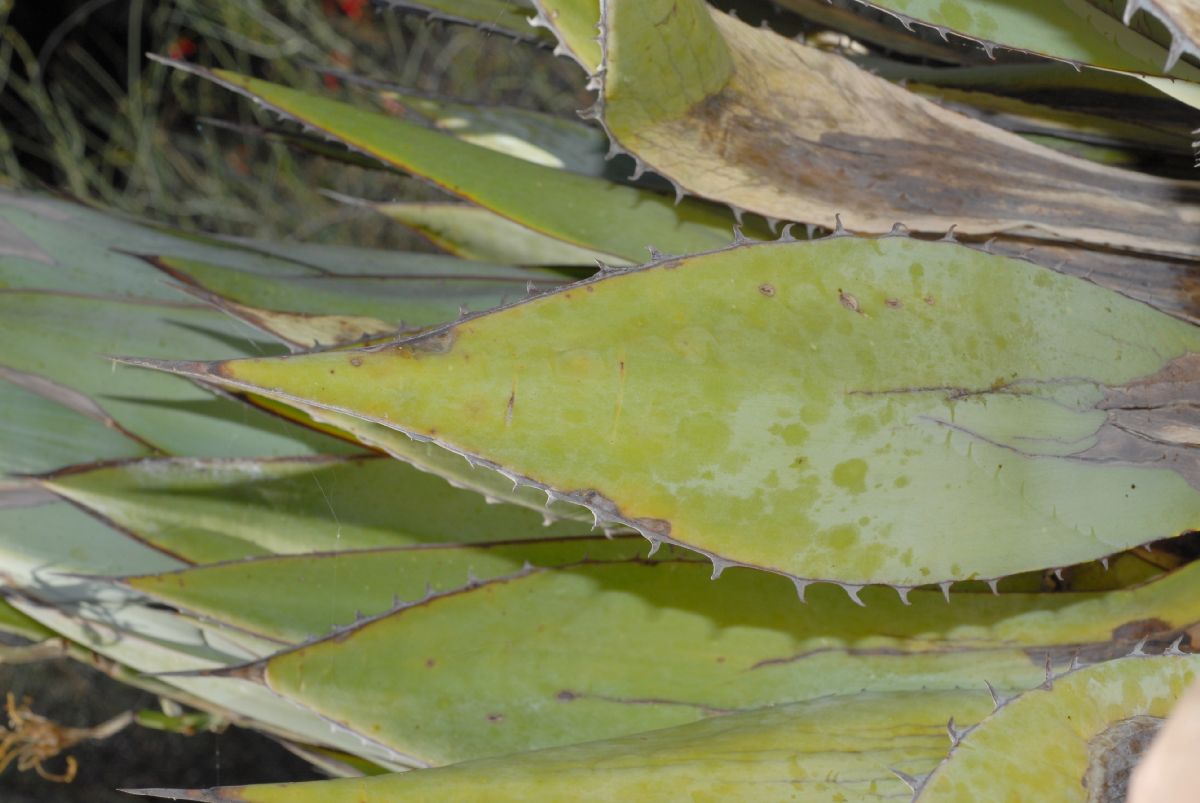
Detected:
left=917, top=654, right=1200, bottom=803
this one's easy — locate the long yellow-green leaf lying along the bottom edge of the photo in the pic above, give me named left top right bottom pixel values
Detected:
left=126, top=691, right=990, bottom=803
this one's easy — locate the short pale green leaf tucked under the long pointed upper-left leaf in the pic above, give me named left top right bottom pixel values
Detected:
left=371, top=202, right=630, bottom=268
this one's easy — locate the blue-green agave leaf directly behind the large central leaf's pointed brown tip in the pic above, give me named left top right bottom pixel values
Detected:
left=0, top=290, right=353, bottom=456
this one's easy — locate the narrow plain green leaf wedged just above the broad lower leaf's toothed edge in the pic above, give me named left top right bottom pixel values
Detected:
left=125, top=535, right=643, bottom=643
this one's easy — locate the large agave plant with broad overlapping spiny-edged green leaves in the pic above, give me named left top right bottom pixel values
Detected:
left=0, top=0, right=1200, bottom=803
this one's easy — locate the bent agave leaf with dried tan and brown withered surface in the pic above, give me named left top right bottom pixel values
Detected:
left=599, top=0, right=1200, bottom=254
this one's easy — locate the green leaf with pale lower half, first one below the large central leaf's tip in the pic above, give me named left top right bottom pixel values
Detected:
left=44, top=457, right=580, bottom=563
